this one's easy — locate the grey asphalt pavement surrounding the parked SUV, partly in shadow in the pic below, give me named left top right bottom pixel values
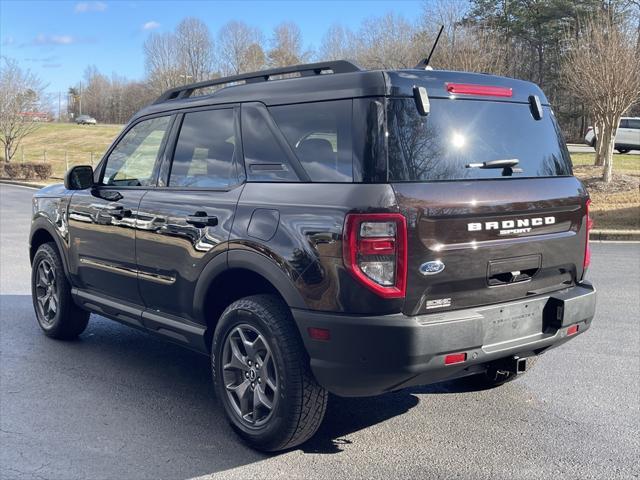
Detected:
left=0, top=185, right=640, bottom=480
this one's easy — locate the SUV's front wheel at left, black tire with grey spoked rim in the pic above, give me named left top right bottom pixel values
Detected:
left=31, top=243, right=89, bottom=340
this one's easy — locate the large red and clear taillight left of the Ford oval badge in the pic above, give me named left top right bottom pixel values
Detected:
left=342, top=213, right=407, bottom=298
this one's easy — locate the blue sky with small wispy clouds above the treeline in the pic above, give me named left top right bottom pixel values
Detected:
left=0, top=0, right=423, bottom=96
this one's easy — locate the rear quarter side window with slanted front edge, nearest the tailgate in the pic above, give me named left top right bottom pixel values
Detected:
left=269, top=100, right=353, bottom=182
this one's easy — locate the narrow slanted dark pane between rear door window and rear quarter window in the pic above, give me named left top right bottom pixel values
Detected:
left=242, top=105, right=298, bottom=182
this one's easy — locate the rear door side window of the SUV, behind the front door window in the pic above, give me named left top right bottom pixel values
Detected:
left=169, top=109, right=236, bottom=188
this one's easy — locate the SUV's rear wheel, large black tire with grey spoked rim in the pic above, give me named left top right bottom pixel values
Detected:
left=211, top=295, right=328, bottom=452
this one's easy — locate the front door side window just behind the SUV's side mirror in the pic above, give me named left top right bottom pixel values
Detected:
left=103, top=117, right=170, bottom=186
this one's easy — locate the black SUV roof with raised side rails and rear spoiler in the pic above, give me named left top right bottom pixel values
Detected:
left=134, top=60, right=548, bottom=118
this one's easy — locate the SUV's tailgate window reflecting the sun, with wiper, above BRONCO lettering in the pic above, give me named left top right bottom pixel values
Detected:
left=387, top=99, right=571, bottom=182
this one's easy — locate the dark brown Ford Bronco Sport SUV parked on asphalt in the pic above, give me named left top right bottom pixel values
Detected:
left=30, top=61, right=595, bottom=451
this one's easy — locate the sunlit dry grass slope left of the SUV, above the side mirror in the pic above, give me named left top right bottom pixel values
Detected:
left=0, top=122, right=123, bottom=178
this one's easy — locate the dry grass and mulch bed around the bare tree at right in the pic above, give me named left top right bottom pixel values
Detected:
left=571, top=153, right=640, bottom=230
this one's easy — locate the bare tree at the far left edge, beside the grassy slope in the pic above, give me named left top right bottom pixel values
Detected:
left=0, top=57, right=43, bottom=162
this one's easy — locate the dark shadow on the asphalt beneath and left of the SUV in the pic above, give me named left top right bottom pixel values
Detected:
left=0, top=295, right=460, bottom=478
